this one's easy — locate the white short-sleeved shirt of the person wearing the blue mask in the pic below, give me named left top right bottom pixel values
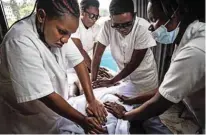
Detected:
left=159, top=21, right=205, bottom=103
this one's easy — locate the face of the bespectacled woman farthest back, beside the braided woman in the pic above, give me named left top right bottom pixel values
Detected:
left=82, top=6, right=99, bottom=28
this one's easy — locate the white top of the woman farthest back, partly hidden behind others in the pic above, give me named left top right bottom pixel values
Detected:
left=71, top=19, right=100, bottom=58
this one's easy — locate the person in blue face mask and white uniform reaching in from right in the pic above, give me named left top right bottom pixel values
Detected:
left=105, top=0, right=205, bottom=133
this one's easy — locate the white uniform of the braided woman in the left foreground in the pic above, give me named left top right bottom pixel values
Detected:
left=0, top=15, right=83, bottom=133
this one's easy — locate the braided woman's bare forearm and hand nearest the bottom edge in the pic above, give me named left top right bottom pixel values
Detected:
left=39, top=92, right=106, bottom=134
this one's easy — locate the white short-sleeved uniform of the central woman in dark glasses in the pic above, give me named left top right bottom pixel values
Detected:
left=98, top=17, right=158, bottom=91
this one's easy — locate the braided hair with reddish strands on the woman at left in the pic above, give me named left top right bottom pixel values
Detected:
left=37, top=0, right=80, bottom=18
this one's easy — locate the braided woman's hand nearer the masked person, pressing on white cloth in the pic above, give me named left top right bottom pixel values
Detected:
left=86, top=100, right=107, bottom=125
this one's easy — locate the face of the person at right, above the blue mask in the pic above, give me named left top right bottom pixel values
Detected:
left=147, top=2, right=178, bottom=32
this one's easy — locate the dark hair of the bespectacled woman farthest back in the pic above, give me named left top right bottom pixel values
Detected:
left=80, top=0, right=99, bottom=11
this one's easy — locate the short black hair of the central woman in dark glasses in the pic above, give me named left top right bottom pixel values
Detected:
left=109, top=0, right=134, bottom=15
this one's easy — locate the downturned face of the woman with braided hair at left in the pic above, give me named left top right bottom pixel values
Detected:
left=37, top=11, right=79, bottom=48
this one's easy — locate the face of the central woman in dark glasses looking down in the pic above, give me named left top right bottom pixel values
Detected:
left=111, top=12, right=135, bottom=36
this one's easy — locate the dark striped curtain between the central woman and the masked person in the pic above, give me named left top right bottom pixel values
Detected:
left=134, top=0, right=174, bottom=84
